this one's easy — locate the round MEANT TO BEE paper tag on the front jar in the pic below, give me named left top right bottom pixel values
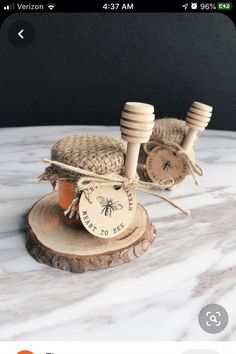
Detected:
left=79, top=186, right=137, bottom=238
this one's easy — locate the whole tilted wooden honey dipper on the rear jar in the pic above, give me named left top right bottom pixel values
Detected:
left=182, top=101, right=213, bottom=154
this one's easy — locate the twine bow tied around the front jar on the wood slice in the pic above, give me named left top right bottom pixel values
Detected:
left=43, top=158, right=190, bottom=215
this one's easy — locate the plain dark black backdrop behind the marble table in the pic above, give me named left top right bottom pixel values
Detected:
left=0, top=13, right=236, bottom=130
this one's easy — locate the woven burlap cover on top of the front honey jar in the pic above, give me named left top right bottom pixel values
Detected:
left=40, top=135, right=125, bottom=180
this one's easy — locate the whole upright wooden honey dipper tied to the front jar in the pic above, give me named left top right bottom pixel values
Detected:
left=120, top=102, right=155, bottom=179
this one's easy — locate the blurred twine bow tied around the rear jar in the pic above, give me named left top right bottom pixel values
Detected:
left=143, top=139, right=203, bottom=185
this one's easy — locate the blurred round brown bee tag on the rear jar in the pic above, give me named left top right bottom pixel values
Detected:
left=146, top=146, right=188, bottom=183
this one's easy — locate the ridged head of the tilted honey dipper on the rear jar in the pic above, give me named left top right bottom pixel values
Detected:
left=186, top=101, right=213, bottom=131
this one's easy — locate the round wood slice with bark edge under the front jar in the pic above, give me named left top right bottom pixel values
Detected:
left=26, top=192, right=155, bottom=272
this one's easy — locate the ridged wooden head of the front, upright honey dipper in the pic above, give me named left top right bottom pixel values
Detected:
left=120, top=102, right=155, bottom=144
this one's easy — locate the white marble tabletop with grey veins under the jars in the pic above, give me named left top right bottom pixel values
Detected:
left=0, top=126, right=236, bottom=341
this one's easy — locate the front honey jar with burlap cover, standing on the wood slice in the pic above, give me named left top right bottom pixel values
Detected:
left=40, top=135, right=125, bottom=227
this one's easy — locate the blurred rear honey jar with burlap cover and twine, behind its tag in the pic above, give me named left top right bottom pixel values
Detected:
left=138, top=118, right=202, bottom=183
